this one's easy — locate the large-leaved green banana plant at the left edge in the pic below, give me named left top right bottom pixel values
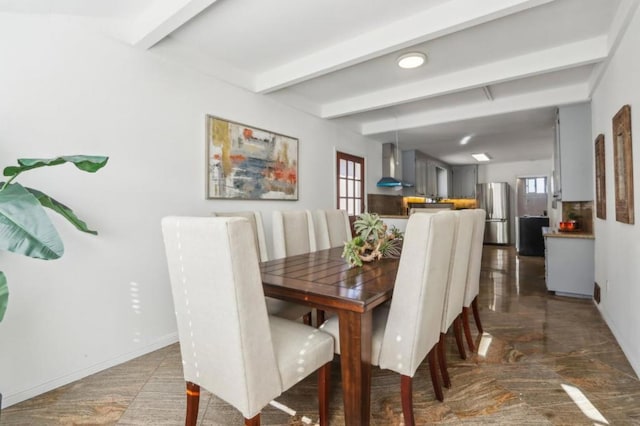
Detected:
left=0, top=155, right=109, bottom=321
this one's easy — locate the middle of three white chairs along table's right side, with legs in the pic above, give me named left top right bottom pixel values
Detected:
left=438, top=210, right=476, bottom=387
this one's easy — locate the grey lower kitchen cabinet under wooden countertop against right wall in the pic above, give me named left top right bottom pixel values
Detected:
left=544, top=233, right=595, bottom=298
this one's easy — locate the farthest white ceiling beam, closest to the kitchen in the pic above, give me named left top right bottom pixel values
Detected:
left=361, top=83, right=589, bottom=136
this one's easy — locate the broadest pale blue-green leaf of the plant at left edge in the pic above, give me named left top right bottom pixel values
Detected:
left=0, top=183, right=64, bottom=259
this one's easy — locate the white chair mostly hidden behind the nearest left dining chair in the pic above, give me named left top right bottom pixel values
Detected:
left=213, top=211, right=311, bottom=325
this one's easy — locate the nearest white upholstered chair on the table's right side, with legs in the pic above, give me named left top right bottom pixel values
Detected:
left=320, top=214, right=455, bottom=426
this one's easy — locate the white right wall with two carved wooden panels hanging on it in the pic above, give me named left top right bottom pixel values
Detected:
left=591, top=2, right=640, bottom=374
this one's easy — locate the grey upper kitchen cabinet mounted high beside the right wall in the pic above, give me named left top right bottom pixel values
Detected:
left=552, top=103, right=594, bottom=201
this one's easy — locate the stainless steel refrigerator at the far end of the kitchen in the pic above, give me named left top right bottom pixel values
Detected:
left=476, top=182, right=511, bottom=244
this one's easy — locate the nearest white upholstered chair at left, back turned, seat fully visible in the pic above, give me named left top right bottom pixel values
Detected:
left=162, top=217, right=333, bottom=425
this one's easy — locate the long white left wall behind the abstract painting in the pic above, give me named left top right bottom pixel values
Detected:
left=0, top=14, right=381, bottom=406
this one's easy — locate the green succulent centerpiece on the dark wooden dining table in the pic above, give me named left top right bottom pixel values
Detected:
left=342, top=213, right=404, bottom=267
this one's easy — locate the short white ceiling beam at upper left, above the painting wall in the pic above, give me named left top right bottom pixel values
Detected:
left=129, top=0, right=216, bottom=49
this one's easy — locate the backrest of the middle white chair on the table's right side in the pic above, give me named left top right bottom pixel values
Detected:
left=439, top=210, right=476, bottom=333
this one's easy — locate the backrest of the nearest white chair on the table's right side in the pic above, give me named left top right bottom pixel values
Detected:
left=379, top=213, right=455, bottom=377
